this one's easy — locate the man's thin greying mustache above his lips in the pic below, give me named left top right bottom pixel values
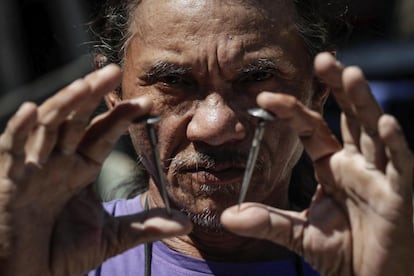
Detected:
left=170, top=148, right=264, bottom=174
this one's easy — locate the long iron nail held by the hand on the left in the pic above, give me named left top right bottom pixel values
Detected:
left=145, top=116, right=171, bottom=215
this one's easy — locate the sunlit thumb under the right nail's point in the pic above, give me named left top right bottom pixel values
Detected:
left=221, top=203, right=306, bottom=255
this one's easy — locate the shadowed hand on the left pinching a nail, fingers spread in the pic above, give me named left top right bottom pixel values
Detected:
left=0, top=65, right=191, bottom=275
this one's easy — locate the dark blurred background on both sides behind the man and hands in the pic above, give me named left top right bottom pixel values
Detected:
left=0, top=0, right=414, bottom=145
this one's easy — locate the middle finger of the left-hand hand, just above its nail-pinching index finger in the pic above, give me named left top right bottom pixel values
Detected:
left=58, top=65, right=121, bottom=155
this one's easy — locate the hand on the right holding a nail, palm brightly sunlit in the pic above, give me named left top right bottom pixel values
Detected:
left=222, top=53, right=414, bottom=275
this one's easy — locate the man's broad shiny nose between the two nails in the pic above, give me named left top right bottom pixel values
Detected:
left=187, top=94, right=246, bottom=146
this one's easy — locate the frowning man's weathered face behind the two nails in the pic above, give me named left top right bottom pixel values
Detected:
left=122, top=0, right=313, bottom=229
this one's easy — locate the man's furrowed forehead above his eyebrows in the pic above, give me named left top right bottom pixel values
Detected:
left=127, top=0, right=306, bottom=75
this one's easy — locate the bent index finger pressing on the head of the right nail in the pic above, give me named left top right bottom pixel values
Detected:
left=257, top=92, right=341, bottom=162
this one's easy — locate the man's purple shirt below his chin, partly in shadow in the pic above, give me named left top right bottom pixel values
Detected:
left=88, top=196, right=319, bottom=276
